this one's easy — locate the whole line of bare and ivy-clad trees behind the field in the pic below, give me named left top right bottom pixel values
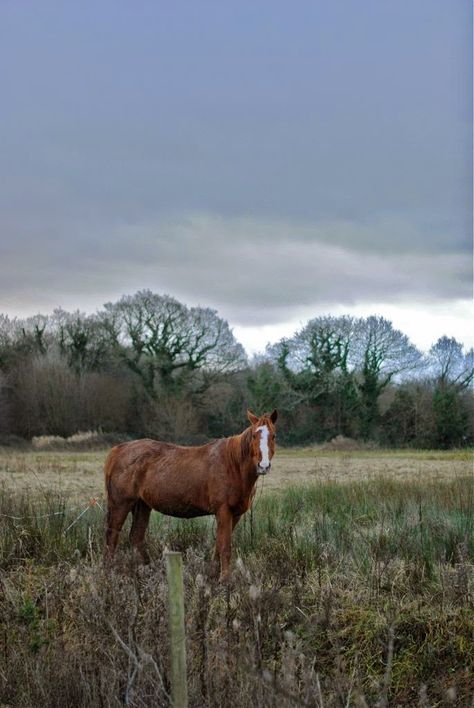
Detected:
left=0, top=290, right=474, bottom=448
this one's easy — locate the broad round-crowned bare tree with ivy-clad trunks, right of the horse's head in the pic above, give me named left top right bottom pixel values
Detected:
left=268, top=316, right=422, bottom=437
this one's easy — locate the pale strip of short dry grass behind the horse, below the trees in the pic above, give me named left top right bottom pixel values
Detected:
left=0, top=448, right=474, bottom=501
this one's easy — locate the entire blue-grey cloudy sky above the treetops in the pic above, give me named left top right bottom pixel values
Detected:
left=0, top=0, right=474, bottom=350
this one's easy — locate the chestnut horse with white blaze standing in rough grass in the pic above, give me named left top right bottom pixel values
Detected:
left=104, top=411, right=277, bottom=579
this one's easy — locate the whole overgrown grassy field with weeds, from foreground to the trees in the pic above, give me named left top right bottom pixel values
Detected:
left=0, top=449, right=474, bottom=708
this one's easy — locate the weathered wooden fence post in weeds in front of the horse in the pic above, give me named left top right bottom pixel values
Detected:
left=165, top=552, right=188, bottom=708
